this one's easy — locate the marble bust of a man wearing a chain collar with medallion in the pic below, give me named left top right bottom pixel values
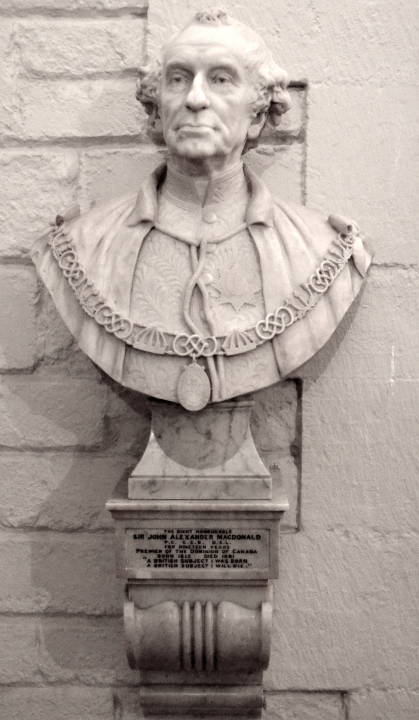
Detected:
left=33, top=10, right=371, bottom=410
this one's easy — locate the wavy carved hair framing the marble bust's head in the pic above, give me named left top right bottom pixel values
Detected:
left=136, top=8, right=291, bottom=151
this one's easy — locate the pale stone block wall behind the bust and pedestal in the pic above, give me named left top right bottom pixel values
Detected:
left=0, top=0, right=419, bottom=720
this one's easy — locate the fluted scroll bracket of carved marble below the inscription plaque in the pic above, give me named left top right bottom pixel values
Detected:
left=124, top=588, right=272, bottom=676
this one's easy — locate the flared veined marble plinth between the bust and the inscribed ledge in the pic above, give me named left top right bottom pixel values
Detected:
left=128, top=399, right=272, bottom=500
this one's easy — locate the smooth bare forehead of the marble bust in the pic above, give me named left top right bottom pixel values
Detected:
left=163, top=23, right=251, bottom=64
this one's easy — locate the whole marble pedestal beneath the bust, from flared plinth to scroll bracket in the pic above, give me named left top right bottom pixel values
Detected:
left=107, top=399, right=288, bottom=718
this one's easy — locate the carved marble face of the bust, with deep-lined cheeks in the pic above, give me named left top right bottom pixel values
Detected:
left=159, top=24, right=256, bottom=163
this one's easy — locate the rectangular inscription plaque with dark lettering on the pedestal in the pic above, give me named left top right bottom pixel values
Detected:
left=126, top=527, right=269, bottom=571
